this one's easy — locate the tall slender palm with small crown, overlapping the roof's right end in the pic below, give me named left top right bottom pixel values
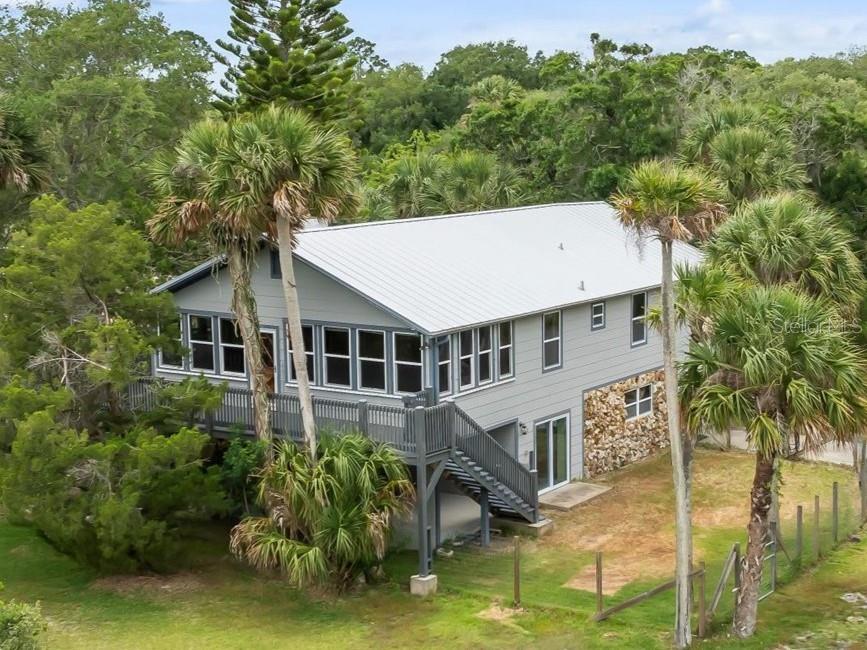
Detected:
left=611, top=160, right=723, bottom=648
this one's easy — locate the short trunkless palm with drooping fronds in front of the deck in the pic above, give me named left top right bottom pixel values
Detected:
left=231, top=434, right=415, bottom=590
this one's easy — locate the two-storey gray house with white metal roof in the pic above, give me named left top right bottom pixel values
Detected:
left=154, top=202, right=700, bottom=588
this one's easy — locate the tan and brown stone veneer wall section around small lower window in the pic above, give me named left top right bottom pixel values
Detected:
left=584, top=370, right=669, bottom=477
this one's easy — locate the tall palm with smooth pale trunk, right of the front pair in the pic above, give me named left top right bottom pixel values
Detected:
left=225, top=106, right=359, bottom=460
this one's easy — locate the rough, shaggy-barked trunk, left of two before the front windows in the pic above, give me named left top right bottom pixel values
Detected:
left=227, top=243, right=274, bottom=463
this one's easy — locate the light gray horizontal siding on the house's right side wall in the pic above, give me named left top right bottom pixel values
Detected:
left=454, top=291, right=662, bottom=478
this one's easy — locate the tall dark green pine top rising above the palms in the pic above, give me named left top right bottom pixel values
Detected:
left=215, top=0, right=357, bottom=122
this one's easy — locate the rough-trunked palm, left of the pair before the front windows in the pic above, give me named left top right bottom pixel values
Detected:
left=148, top=120, right=273, bottom=459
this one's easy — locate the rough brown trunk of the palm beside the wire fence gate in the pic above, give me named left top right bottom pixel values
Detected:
left=733, top=454, right=774, bottom=639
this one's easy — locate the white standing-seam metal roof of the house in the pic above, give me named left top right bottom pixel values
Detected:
left=159, top=202, right=701, bottom=334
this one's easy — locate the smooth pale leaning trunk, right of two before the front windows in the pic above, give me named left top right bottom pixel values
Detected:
left=277, top=217, right=316, bottom=462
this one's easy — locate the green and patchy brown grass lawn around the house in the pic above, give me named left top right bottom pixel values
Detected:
left=0, top=451, right=867, bottom=649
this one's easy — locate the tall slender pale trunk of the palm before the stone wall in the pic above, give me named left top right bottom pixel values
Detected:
left=661, top=240, right=692, bottom=648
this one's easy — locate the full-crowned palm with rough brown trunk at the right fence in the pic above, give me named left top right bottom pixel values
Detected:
left=681, top=286, right=867, bottom=637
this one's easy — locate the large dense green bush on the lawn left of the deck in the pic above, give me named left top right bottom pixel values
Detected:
left=2, top=411, right=226, bottom=571
